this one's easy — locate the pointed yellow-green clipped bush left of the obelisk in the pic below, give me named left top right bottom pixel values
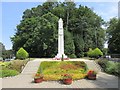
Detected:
left=16, top=48, right=29, bottom=59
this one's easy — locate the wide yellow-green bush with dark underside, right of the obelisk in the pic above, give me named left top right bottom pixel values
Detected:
left=87, top=48, right=103, bottom=58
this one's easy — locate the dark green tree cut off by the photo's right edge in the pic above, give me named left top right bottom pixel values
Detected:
left=107, top=18, right=120, bottom=54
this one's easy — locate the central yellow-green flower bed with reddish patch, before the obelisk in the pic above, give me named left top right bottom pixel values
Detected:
left=37, top=61, right=87, bottom=80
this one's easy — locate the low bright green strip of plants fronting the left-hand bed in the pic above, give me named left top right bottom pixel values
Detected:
left=0, top=69, right=19, bottom=77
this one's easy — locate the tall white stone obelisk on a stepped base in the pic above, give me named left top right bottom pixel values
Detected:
left=55, top=18, right=67, bottom=59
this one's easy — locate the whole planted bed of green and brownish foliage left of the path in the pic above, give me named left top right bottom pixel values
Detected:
left=0, top=60, right=28, bottom=77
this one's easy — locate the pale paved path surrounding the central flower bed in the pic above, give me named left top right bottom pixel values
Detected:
left=2, top=59, right=118, bottom=88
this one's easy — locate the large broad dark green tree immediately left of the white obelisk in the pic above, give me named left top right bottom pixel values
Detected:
left=11, top=13, right=58, bottom=57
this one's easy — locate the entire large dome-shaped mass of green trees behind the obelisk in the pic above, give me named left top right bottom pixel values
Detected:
left=11, top=2, right=105, bottom=57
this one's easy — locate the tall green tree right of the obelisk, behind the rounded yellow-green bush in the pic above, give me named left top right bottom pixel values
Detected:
left=69, top=5, right=105, bottom=57
